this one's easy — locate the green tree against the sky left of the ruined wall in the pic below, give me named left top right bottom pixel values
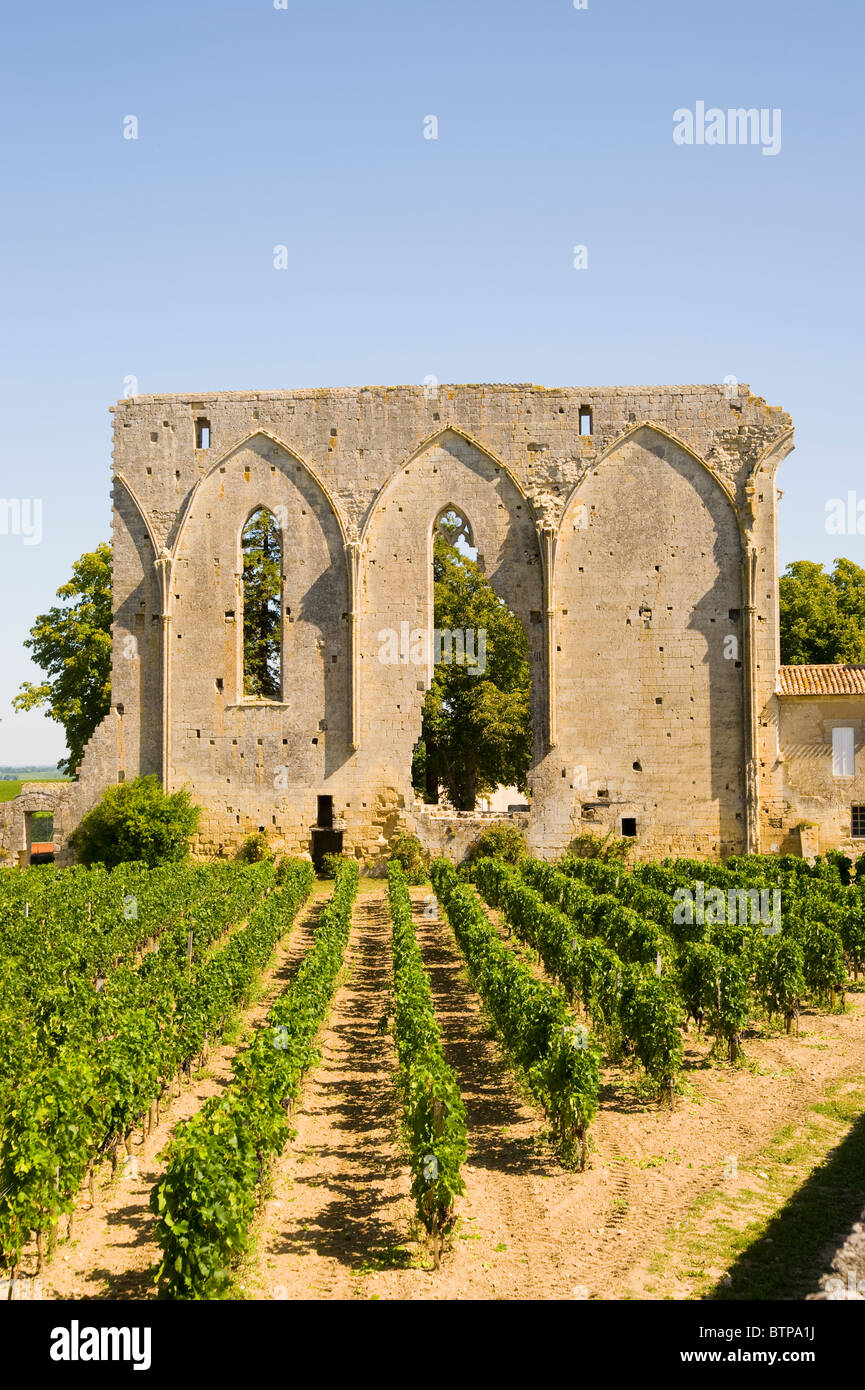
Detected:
left=13, top=541, right=111, bottom=773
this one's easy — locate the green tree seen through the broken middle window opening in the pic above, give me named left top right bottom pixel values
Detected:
left=413, top=535, right=531, bottom=810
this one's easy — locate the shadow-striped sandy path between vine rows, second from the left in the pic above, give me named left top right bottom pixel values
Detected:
left=241, top=887, right=417, bottom=1298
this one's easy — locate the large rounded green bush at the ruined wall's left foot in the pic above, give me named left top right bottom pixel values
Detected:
left=70, top=774, right=202, bottom=869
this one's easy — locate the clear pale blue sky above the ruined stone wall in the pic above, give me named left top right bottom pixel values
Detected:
left=0, top=0, right=865, bottom=763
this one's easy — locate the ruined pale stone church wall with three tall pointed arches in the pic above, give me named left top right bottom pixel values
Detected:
left=66, top=385, right=791, bottom=855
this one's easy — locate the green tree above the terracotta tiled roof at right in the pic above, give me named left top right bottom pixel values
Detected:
left=780, top=560, right=865, bottom=666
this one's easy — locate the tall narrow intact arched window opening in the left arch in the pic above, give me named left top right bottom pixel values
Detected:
left=241, top=507, right=282, bottom=701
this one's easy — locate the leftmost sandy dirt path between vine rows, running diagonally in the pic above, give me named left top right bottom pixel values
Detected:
left=33, top=884, right=332, bottom=1300
